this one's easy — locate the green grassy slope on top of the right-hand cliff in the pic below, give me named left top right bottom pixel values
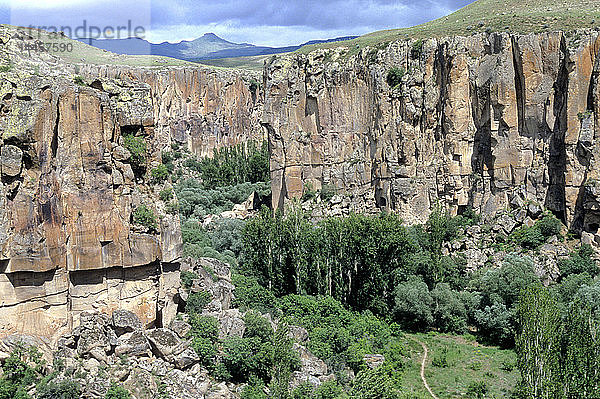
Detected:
left=298, top=0, right=600, bottom=53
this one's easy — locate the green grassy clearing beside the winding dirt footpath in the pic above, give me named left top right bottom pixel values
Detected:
left=404, top=334, right=519, bottom=399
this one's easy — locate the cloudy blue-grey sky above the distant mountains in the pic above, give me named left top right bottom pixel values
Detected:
left=0, top=0, right=472, bottom=46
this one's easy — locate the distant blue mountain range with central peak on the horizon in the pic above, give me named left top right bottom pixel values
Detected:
left=79, top=33, right=357, bottom=61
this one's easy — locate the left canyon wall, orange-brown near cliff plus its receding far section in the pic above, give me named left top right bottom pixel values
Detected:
left=0, top=27, right=261, bottom=338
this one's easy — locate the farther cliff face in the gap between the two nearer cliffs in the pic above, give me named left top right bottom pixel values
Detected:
left=81, top=66, right=267, bottom=157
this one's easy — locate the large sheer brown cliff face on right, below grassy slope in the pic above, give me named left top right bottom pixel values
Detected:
left=263, top=31, right=600, bottom=230
